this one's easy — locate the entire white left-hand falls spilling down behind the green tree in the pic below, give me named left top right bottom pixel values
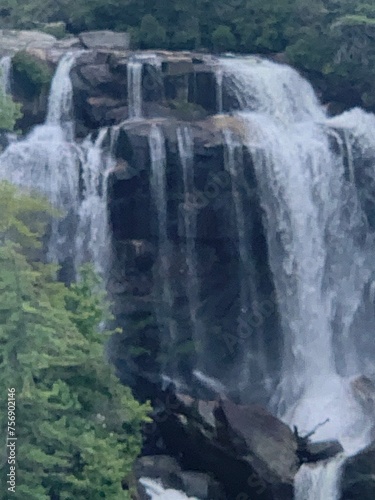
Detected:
left=0, top=52, right=113, bottom=276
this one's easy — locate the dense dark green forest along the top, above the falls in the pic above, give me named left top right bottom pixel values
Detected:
left=0, top=0, right=375, bottom=110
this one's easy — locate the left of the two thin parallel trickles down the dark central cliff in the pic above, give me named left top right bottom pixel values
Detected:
left=149, top=124, right=177, bottom=365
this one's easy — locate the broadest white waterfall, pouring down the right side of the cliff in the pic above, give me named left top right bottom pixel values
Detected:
left=222, top=58, right=375, bottom=500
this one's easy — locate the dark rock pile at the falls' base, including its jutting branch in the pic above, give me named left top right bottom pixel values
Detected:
left=125, top=386, right=349, bottom=500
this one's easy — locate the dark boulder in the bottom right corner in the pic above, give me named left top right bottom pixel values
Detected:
left=341, top=441, right=375, bottom=500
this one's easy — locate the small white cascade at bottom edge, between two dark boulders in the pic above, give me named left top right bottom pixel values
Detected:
left=294, top=455, right=345, bottom=500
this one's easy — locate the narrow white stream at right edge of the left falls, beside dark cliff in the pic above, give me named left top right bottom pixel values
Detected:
left=75, top=128, right=114, bottom=277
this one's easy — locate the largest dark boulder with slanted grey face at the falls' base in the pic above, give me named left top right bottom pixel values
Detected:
left=156, top=394, right=298, bottom=500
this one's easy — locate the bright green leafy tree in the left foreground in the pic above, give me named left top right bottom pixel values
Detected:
left=0, top=184, right=149, bottom=500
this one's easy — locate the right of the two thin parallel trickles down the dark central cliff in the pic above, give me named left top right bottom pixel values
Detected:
left=177, top=127, right=204, bottom=360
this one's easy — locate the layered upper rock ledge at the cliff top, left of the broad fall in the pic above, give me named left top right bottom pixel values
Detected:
left=0, top=30, right=229, bottom=137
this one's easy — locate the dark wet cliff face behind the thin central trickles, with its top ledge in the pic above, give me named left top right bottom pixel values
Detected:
left=0, top=32, right=280, bottom=402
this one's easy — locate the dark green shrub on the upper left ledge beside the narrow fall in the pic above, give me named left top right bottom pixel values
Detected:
left=13, top=51, right=53, bottom=98
